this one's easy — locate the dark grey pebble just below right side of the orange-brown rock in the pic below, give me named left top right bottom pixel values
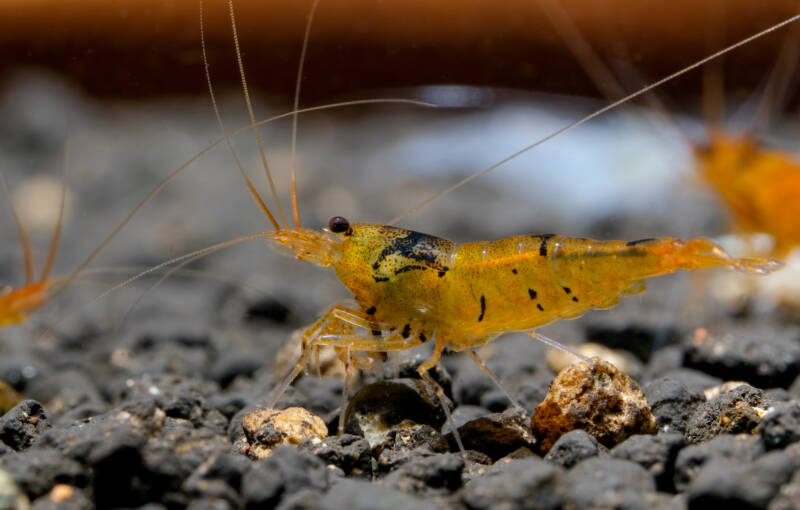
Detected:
left=611, top=434, right=686, bottom=492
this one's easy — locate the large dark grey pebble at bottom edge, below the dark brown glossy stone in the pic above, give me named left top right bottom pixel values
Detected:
left=461, top=457, right=565, bottom=510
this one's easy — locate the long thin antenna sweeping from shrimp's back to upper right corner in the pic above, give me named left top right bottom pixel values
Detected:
left=388, top=14, right=800, bottom=225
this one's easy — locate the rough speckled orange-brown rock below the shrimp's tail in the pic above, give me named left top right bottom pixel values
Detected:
left=531, top=358, right=656, bottom=452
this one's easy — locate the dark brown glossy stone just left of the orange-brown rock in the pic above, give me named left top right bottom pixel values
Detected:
left=449, top=407, right=536, bottom=460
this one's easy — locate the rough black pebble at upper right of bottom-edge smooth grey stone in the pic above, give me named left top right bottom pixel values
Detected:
left=383, top=453, right=464, bottom=496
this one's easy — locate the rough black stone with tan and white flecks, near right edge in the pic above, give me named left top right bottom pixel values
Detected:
left=686, top=384, right=771, bottom=443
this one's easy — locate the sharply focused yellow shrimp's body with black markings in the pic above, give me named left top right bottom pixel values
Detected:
left=270, top=217, right=781, bottom=382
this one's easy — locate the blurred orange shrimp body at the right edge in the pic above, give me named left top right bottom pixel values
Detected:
left=694, top=130, right=800, bottom=255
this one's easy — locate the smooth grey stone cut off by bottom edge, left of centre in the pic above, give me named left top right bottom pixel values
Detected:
left=316, top=480, right=436, bottom=510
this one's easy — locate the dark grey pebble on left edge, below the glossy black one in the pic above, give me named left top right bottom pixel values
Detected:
left=0, top=446, right=90, bottom=499
